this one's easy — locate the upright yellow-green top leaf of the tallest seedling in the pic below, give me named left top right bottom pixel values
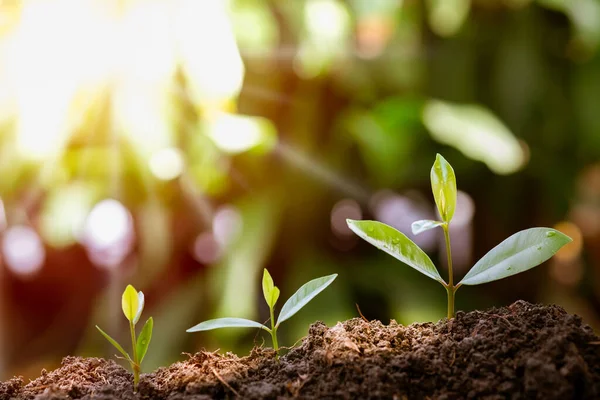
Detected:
left=431, top=154, right=456, bottom=223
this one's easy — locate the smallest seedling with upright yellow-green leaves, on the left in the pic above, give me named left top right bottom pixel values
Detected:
left=96, top=285, right=154, bottom=390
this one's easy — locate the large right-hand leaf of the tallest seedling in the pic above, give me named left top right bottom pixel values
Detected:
left=459, top=228, right=572, bottom=285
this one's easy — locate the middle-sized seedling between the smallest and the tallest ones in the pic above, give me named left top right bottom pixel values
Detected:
left=187, top=269, right=337, bottom=352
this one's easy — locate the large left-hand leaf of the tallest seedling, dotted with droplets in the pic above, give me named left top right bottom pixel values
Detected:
left=347, top=219, right=446, bottom=285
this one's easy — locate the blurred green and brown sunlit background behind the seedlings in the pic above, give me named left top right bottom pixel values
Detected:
left=0, top=0, right=600, bottom=379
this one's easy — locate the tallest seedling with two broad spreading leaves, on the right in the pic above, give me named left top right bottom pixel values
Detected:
left=347, top=154, right=571, bottom=318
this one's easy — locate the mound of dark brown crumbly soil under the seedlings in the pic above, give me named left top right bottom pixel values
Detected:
left=0, top=301, right=600, bottom=400
